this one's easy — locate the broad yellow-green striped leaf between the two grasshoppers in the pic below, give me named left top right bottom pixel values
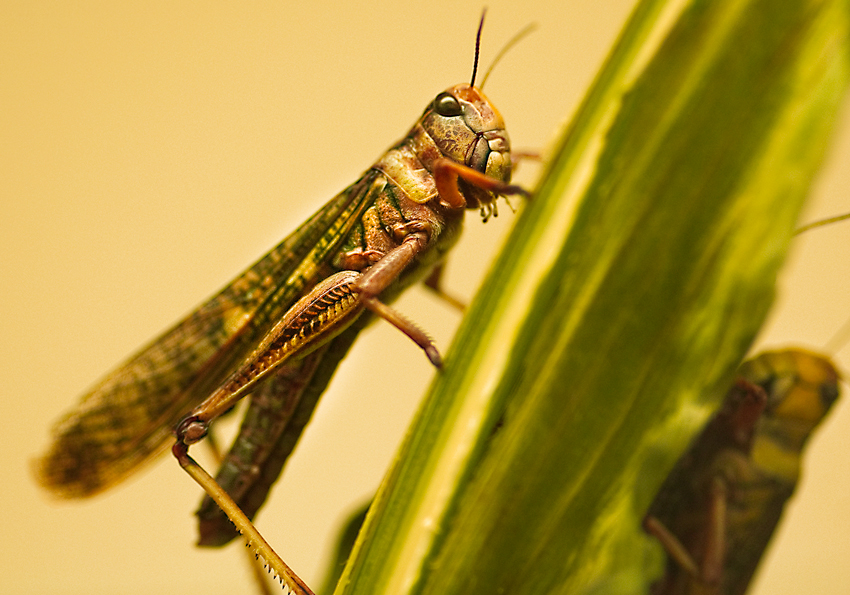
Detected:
left=337, top=0, right=850, bottom=595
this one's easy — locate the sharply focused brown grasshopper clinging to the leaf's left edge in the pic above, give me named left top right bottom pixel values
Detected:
left=38, top=11, right=525, bottom=589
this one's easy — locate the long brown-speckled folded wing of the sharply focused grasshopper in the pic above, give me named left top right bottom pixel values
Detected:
left=37, top=170, right=386, bottom=498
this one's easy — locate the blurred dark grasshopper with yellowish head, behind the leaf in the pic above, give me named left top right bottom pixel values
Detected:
left=644, top=349, right=839, bottom=595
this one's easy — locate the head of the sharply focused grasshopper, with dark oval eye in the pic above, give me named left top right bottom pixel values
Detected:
left=421, top=84, right=511, bottom=208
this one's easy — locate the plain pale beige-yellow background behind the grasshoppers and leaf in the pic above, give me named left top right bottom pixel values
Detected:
left=0, top=0, right=850, bottom=594
